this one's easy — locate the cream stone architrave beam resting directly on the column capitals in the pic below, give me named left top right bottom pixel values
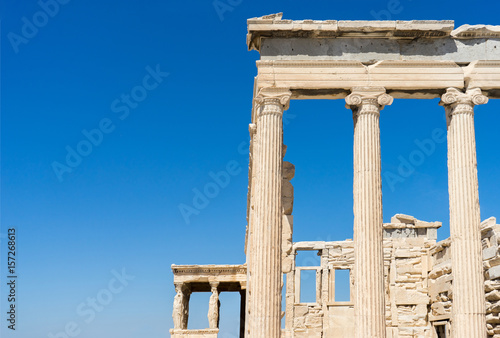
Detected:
left=255, top=60, right=500, bottom=99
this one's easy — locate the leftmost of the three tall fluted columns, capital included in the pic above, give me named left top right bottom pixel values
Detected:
left=248, top=88, right=291, bottom=338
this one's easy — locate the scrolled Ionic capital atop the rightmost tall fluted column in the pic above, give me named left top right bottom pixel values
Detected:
left=439, top=88, right=488, bottom=115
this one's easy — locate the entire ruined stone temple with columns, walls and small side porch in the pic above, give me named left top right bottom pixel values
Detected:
left=170, top=14, right=500, bottom=338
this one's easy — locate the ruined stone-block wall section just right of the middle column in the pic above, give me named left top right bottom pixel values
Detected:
left=384, top=214, right=441, bottom=338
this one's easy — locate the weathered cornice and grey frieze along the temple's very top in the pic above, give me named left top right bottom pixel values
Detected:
left=247, top=14, right=500, bottom=63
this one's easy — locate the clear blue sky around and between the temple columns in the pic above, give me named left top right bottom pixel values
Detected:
left=0, top=0, right=500, bottom=338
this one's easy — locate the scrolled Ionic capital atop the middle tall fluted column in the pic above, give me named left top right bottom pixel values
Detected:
left=345, top=87, right=394, bottom=114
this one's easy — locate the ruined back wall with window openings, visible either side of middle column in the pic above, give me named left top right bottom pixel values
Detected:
left=285, top=215, right=441, bottom=338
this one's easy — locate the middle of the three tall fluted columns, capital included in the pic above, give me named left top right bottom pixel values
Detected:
left=346, top=87, right=393, bottom=338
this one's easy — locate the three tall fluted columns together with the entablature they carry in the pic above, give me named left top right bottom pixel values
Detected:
left=245, top=14, right=500, bottom=338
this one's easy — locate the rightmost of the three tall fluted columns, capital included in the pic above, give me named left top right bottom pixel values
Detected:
left=440, top=88, right=488, bottom=338
